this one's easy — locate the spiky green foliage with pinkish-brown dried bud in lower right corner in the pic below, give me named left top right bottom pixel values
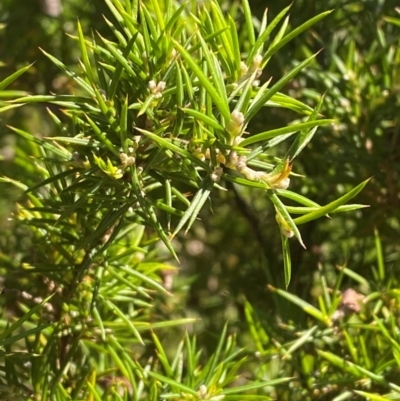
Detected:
left=245, top=228, right=400, bottom=400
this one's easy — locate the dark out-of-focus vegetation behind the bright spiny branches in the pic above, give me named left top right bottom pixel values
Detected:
left=0, top=0, right=400, bottom=399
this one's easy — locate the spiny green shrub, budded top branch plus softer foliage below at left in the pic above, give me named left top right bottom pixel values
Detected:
left=0, top=0, right=376, bottom=400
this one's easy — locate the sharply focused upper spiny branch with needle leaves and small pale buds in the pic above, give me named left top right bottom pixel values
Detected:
left=8, top=1, right=365, bottom=284
